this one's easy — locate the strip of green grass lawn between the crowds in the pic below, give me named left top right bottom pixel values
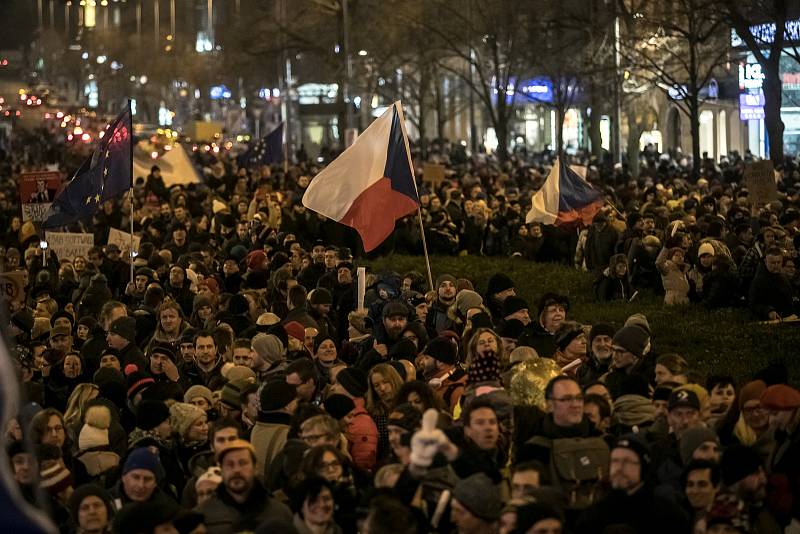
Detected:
left=370, top=255, right=800, bottom=382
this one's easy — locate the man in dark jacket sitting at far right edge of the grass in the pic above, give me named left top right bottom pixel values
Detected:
left=750, top=247, right=793, bottom=321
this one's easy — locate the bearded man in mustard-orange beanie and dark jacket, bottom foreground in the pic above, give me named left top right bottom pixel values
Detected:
left=196, top=439, right=292, bottom=534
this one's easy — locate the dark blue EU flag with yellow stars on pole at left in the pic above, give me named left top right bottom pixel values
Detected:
left=42, top=105, right=133, bottom=228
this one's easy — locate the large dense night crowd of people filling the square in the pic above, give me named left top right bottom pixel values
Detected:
left=0, top=129, right=800, bottom=534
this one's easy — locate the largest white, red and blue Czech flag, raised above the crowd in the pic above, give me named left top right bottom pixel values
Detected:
left=303, top=102, right=419, bottom=252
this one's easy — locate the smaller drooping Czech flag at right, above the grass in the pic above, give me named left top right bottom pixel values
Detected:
left=525, top=158, right=605, bottom=226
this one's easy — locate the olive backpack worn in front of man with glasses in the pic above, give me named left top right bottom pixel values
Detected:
left=527, top=436, right=610, bottom=510
